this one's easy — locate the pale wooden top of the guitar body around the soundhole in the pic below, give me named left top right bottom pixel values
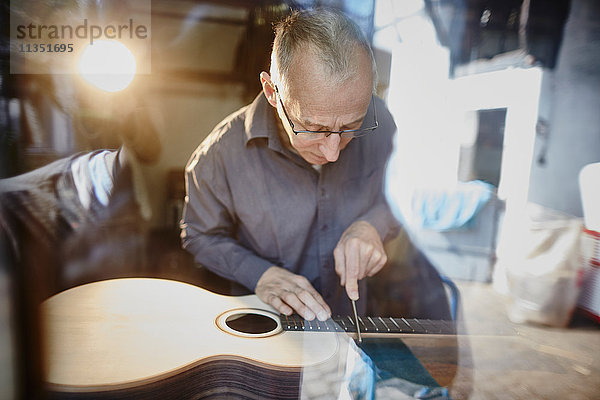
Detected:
left=42, top=278, right=346, bottom=390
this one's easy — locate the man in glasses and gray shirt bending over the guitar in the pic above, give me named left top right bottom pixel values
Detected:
left=182, top=10, right=398, bottom=320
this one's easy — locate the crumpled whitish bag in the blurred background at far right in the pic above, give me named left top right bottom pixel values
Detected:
left=496, top=205, right=585, bottom=327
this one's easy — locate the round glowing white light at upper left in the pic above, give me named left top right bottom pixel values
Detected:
left=79, top=40, right=136, bottom=92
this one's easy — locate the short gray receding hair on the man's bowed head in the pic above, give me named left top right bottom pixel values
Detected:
left=270, top=8, right=377, bottom=96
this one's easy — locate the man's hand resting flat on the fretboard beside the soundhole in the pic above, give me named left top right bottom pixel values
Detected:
left=256, top=266, right=331, bottom=321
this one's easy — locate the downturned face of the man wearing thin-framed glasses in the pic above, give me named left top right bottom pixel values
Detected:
left=278, top=46, right=373, bottom=165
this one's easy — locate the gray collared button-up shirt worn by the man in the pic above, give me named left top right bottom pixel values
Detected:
left=182, top=94, right=398, bottom=315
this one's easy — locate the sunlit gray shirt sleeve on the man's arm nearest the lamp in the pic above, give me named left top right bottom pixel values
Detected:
left=181, top=144, right=272, bottom=291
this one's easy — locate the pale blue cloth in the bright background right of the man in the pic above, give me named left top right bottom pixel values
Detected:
left=412, top=181, right=494, bottom=231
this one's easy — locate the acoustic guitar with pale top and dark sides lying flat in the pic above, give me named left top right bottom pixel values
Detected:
left=42, top=278, right=452, bottom=399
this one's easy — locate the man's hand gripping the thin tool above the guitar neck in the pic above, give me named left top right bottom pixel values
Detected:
left=333, top=221, right=387, bottom=300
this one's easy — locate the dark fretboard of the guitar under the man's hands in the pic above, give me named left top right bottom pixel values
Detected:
left=279, top=314, right=456, bottom=335
